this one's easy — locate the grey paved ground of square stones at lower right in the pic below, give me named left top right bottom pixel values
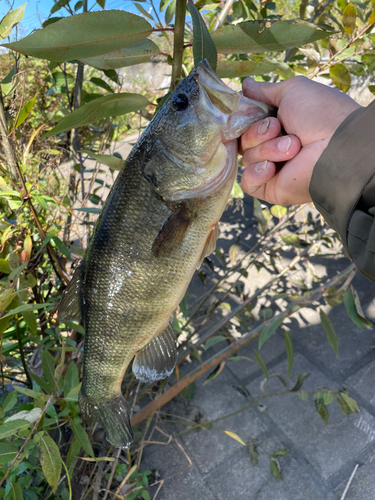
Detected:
left=138, top=193, right=375, bottom=500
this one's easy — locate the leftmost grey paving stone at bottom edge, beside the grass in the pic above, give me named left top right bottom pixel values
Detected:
left=141, top=442, right=217, bottom=500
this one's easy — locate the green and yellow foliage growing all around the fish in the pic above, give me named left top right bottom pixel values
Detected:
left=0, top=0, right=375, bottom=500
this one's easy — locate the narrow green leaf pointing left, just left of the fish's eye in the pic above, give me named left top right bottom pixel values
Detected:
left=43, top=93, right=148, bottom=139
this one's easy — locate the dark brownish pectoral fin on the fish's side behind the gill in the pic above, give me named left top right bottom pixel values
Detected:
left=152, top=204, right=195, bottom=257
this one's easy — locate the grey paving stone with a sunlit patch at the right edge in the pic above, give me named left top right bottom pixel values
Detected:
left=247, top=354, right=375, bottom=480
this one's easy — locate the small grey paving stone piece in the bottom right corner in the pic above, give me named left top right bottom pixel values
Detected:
left=335, top=455, right=375, bottom=500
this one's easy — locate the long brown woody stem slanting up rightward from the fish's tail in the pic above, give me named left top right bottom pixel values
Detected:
left=131, top=264, right=355, bottom=426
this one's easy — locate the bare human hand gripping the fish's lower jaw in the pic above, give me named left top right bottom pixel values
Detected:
left=240, top=76, right=360, bottom=205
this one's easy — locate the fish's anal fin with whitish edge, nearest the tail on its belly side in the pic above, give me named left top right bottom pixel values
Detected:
left=133, top=325, right=177, bottom=383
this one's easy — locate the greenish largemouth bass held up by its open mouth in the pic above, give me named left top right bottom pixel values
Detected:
left=58, top=60, right=273, bottom=448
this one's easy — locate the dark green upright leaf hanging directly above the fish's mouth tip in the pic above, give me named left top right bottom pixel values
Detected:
left=187, top=0, right=217, bottom=71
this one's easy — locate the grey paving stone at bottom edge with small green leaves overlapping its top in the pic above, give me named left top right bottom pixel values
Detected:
left=205, top=436, right=327, bottom=500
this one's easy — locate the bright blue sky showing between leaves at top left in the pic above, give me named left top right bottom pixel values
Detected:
left=0, top=0, right=136, bottom=35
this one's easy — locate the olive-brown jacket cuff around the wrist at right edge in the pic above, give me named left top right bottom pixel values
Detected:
left=309, top=101, right=375, bottom=254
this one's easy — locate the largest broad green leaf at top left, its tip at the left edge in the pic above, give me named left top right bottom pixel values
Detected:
left=3, top=10, right=152, bottom=62
